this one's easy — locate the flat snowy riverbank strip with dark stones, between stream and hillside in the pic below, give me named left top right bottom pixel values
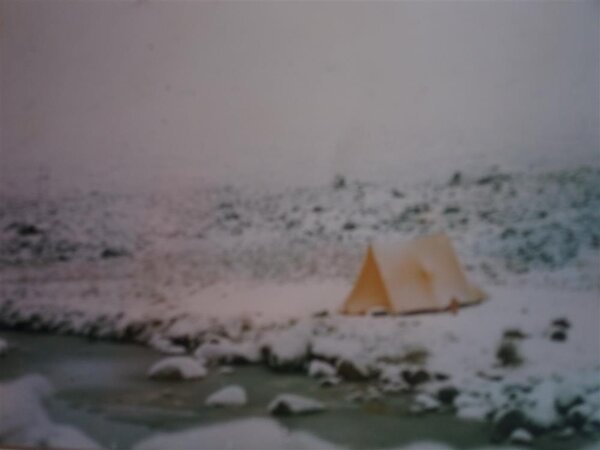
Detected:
left=0, top=281, right=600, bottom=442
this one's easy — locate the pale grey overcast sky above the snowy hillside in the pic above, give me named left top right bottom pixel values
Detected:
left=0, top=0, right=600, bottom=196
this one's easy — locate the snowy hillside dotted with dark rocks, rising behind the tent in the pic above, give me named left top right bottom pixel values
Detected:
left=0, top=168, right=600, bottom=289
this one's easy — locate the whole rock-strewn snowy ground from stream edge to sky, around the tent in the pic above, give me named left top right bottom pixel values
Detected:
left=0, top=168, right=600, bottom=446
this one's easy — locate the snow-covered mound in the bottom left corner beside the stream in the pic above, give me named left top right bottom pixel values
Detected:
left=0, top=375, right=100, bottom=449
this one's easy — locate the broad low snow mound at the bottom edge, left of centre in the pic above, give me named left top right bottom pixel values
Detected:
left=134, top=418, right=338, bottom=450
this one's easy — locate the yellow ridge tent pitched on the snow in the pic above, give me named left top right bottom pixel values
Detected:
left=342, top=234, right=485, bottom=314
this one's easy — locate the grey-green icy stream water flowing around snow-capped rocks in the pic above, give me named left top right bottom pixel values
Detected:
left=0, top=331, right=590, bottom=450
